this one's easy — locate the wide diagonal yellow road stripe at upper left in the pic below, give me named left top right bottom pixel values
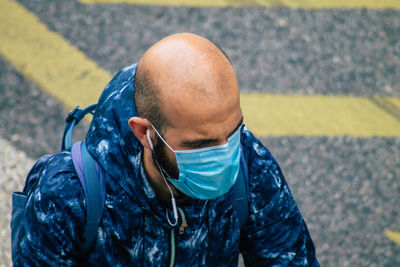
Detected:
left=0, top=0, right=111, bottom=110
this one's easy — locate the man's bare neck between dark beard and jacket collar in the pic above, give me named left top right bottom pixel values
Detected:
left=143, top=148, right=182, bottom=204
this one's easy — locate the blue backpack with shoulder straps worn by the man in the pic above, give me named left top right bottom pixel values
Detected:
left=10, top=104, right=248, bottom=259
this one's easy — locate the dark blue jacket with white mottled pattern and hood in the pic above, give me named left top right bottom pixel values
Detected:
left=13, top=65, right=319, bottom=267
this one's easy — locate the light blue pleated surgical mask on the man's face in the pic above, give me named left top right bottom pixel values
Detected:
left=147, top=126, right=241, bottom=199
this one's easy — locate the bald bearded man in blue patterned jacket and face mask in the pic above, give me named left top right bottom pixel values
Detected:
left=13, top=33, right=319, bottom=266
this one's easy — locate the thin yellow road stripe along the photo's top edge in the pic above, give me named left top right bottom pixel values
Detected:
left=79, top=0, right=400, bottom=9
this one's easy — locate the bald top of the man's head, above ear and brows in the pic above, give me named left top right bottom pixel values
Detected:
left=135, top=33, right=239, bottom=134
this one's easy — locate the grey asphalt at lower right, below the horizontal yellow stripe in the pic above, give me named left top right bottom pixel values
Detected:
left=262, top=137, right=400, bottom=266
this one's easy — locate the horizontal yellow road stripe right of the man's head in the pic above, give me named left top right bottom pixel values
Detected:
left=241, top=93, right=400, bottom=137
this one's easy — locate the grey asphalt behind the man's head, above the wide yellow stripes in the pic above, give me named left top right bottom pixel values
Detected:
left=19, top=0, right=400, bottom=96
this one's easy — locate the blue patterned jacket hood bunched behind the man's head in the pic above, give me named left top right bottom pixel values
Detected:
left=86, top=64, right=162, bottom=222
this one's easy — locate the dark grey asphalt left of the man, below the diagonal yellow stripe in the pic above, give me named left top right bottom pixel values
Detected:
left=0, top=56, right=87, bottom=158
